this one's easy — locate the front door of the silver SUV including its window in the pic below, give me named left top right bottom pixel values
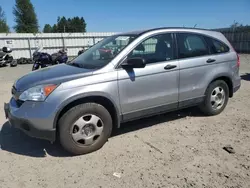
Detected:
left=118, top=33, right=179, bottom=121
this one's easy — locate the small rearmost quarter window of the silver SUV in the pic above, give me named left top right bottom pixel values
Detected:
left=206, top=37, right=229, bottom=54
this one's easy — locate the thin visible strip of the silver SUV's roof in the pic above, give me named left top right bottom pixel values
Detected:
left=119, top=27, right=216, bottom=35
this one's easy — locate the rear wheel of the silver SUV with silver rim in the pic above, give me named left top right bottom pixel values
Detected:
left=200, top=80, right=229, bottom=116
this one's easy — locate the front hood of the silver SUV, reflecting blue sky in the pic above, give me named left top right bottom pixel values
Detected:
left=14, top=64, right=93, bottom=92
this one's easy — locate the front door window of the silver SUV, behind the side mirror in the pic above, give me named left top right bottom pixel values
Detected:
left=128, top=33, right=174, bottom=64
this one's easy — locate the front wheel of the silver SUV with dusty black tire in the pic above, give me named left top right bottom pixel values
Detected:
left=58, top=103, right=112, bottom=155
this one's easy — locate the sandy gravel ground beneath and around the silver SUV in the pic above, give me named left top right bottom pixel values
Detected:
left=0, top=55, right=250, bottom=188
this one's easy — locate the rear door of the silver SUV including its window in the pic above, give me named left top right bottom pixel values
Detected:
left=176, top=32, right=216, bottom=107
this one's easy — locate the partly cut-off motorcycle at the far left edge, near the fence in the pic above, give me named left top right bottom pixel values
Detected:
left=0, top=47, right=17, bottom=67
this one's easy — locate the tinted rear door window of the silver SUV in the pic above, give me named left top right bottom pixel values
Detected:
left=177, top=33, right=209, bottom=58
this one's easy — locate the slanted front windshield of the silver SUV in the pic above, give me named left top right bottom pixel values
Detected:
left=69, top=35, right=137, bottom=69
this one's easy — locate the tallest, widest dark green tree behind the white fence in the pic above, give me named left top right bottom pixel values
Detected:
left=13, top=0, right=39, bottom=33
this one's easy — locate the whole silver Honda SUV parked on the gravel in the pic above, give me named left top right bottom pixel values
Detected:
left=5, top=28, right=241, bottom=155
